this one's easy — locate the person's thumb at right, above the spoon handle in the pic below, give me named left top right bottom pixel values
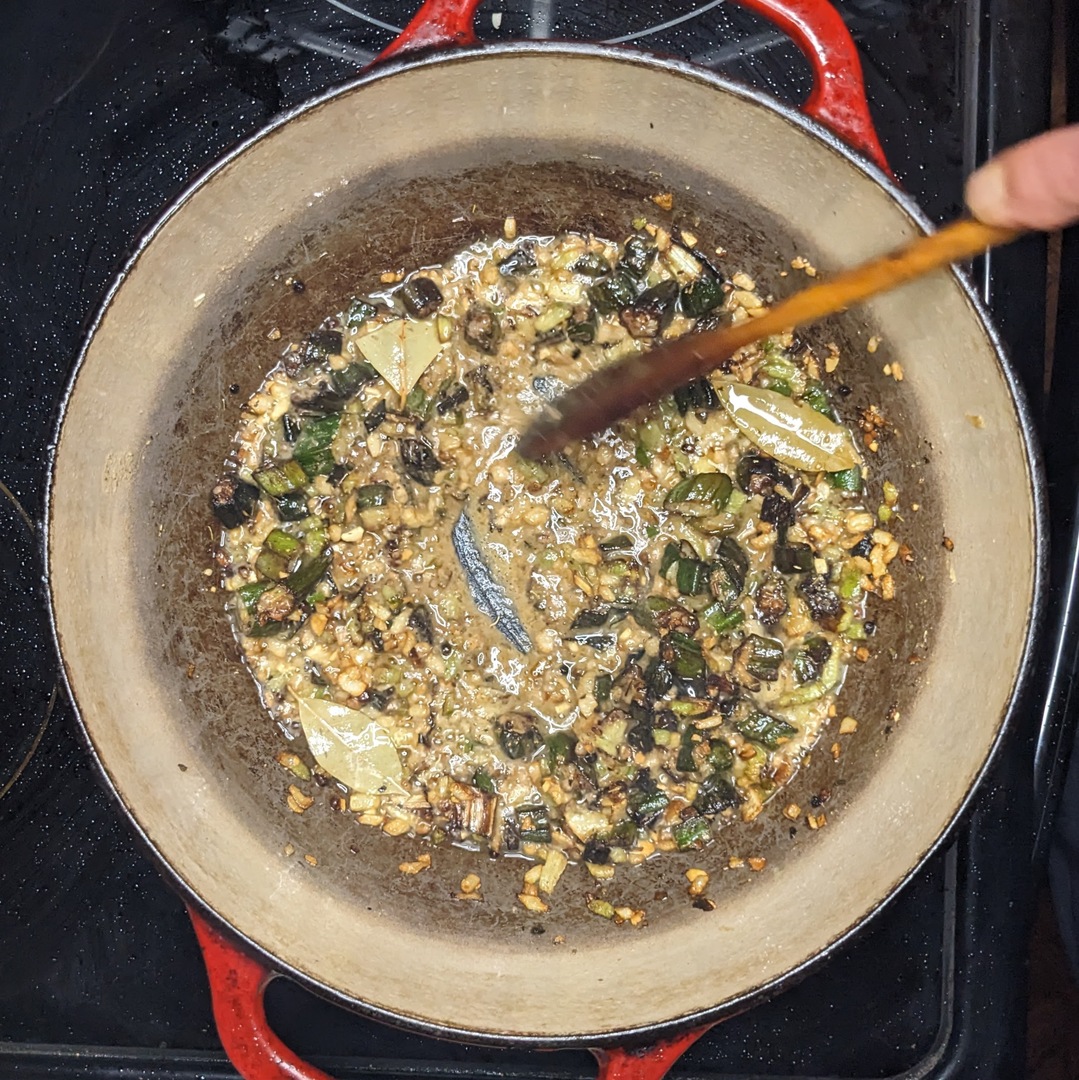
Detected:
left=966, top=124, right=1079, bottom=235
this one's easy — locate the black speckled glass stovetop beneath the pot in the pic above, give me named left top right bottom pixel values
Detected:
left=0, top=0, right=1079, bottom=1080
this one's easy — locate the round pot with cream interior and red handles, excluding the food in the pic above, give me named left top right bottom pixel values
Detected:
left=48, top=0, right=1043, bottom=1077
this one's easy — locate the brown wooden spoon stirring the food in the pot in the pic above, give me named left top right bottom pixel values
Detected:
left=517, top=218, right=1020, bottom=458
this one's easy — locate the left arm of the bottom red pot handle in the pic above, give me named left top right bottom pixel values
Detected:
left=187, top=906, right=332, bottom=1080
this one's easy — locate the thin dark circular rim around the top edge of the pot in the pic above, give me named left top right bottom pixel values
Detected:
left=41, top=41, right=1049, bottom=1050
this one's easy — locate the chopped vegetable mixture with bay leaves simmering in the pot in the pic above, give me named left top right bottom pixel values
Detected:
left=212, top=220, right=900, bottom=892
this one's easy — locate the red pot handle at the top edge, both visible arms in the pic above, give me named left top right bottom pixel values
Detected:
left=374, top=0, right=892, bottom=176
